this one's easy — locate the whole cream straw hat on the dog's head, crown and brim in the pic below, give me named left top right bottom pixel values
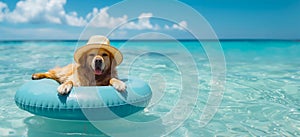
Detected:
left=74, top=35, right=123, bottom=65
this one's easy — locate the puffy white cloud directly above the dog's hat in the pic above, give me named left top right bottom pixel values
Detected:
left=86, top=7, right=127, bottom=28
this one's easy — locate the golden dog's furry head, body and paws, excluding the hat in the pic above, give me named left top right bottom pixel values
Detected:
left=32, top=49, right=126, bottom=94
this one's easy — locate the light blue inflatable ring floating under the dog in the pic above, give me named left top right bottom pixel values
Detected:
left=15, top=78, right=152, bottom=120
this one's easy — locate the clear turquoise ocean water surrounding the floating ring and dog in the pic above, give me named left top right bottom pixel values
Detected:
left=0, top=41, right=300, bottom=136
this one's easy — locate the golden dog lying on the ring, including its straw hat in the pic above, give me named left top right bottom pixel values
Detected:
left=32, top=35, right=126, bottom=95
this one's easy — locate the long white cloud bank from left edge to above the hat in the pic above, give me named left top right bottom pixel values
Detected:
left=0, top=0, right=127, bottom=28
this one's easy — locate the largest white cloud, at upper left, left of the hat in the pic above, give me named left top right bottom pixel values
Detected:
left=3, top=0, right=86, bottom=26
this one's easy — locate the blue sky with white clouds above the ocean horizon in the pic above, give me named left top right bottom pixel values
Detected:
left=0, top=0, right=300, bottom=40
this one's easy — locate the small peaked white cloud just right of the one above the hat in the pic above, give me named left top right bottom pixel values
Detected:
left=122, top=13, right=159, bottom=30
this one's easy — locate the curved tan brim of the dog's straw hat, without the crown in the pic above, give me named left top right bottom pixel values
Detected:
left=74, top=44, right=123, bottom=65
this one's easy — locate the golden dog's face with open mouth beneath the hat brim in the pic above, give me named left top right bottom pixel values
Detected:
left=79, top=49, right=113, bottom=75
